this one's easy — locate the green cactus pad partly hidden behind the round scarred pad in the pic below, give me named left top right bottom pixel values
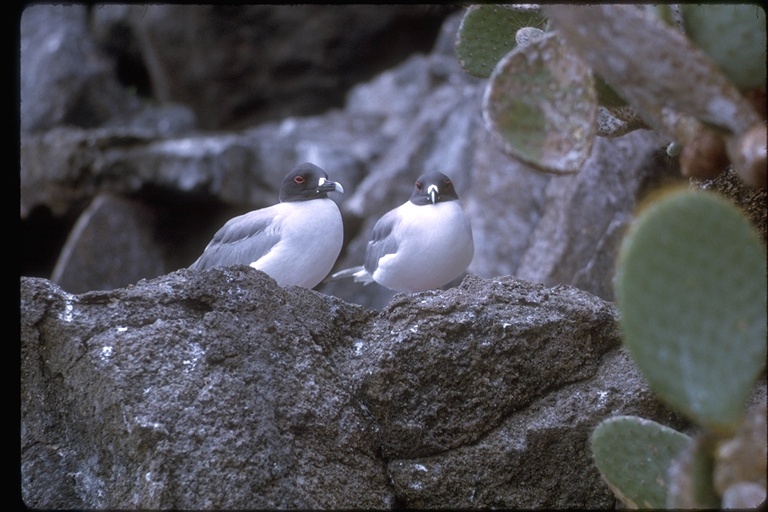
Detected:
left=456, top=5, right=546, bottom=78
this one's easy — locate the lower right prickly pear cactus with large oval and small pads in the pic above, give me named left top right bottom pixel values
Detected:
left=591, top=189, right=768, bottom=509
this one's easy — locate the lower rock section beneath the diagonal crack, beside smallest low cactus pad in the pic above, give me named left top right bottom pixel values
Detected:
left=388, top=349, right=682, bottom=510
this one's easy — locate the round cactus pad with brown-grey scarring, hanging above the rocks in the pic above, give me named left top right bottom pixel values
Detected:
left=483, top=33, right=597, bottom=174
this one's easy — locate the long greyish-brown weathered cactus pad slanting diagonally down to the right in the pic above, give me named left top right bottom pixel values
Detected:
left=544, top=4, right=765, bottom=136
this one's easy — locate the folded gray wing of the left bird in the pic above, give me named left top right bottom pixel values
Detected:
left=190, top=208, right=280, bottom=269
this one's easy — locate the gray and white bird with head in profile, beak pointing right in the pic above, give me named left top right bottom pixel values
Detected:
left=189, top=163, right=344, bottom=288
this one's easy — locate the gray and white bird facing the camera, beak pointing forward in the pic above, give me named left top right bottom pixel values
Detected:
left=331, top=172, right=475, bottom=292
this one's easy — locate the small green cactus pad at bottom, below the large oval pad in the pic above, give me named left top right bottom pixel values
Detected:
left=590, top=416, right=691, bottom=509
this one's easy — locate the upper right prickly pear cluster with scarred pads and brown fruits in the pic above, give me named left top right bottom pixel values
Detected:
left=456, top=4, right=768, bottom=187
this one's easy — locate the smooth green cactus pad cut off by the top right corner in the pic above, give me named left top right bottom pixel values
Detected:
left=682, top=4, right=766, bottom=90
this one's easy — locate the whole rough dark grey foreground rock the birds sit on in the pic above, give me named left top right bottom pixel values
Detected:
left=21, top=267, right=679, bottom=509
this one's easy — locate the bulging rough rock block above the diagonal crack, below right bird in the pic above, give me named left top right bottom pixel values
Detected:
left=354, top=276, right=620, bottom=458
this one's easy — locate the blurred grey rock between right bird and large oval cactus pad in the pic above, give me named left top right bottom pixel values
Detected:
left=515, top=130, right=683, bottom=300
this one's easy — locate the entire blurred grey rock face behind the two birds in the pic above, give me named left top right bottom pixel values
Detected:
left=20, top=5, right=760, bottom=308
